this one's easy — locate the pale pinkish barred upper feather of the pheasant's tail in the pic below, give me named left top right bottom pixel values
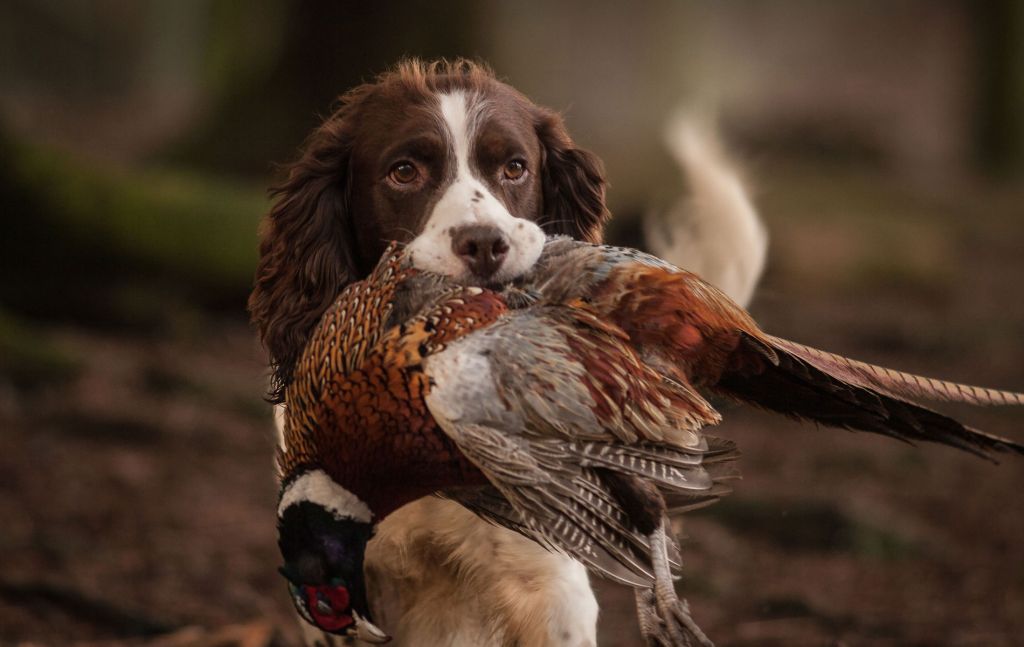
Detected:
left=766, top=336, right=1024, bottom=406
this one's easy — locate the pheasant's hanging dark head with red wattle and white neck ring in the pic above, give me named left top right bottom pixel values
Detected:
left=278, top=470, right=390, bottom=643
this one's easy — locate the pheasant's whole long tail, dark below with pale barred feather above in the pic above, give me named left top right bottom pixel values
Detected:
left=712, top=333, right=1024, bottom=459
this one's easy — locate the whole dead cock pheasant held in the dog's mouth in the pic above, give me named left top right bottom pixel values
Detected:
left=278, top=239, right=1024, bottom=645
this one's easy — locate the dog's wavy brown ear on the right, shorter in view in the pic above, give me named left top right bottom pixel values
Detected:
left=535, top=109, right=609, bottom=243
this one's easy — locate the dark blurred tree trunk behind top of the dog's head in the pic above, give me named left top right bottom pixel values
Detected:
left=162, top=0, right=480, bottom=177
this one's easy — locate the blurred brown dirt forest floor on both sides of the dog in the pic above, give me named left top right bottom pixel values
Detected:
left=0, top=163, right=1024, bottom=646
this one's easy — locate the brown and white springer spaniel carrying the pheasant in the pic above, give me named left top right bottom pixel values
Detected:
left=249, top=60, right=763, bottom=647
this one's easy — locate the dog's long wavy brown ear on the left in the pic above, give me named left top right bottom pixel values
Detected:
left=249, top=101, right=355, bottom=402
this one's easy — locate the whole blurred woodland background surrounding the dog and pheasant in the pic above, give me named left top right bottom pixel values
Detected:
left=0, top=0, right=1024, bottom=647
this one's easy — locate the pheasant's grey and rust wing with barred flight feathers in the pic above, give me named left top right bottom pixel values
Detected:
left=424, top=306, right=735, bottom=586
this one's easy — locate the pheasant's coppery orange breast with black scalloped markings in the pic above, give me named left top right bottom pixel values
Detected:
left=278, top=251, right=505, bottom=516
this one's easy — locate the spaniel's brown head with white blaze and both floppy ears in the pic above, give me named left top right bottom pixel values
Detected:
left=249, top=60, right=608, bottom=399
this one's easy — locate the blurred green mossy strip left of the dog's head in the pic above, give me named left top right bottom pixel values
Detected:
left=7, top=136, right=266, bottom=287
